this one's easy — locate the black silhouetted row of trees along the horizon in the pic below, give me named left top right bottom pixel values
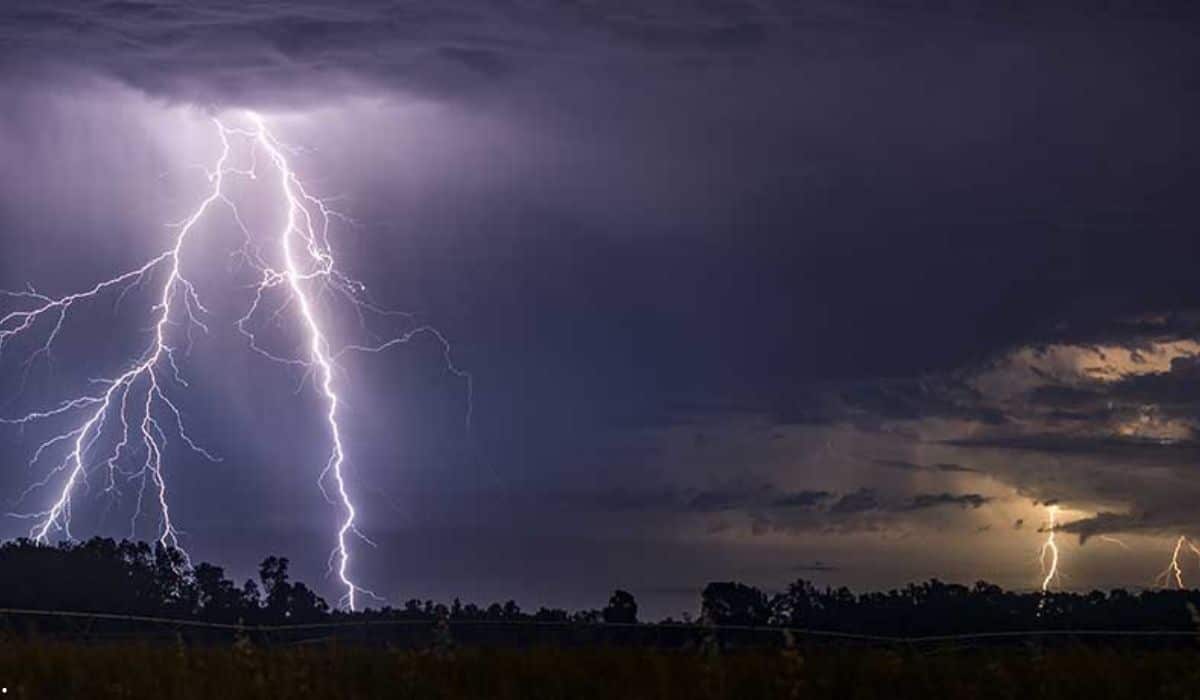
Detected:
left=0, top=538, right=1200, bottom=636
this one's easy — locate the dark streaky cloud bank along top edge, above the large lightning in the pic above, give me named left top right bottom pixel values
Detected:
left=0, top=0, right=820, bottom=103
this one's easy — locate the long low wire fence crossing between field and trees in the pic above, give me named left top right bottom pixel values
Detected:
left=0, top=608, right=1200, bottom=650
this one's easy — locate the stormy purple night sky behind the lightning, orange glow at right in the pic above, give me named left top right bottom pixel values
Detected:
left=0, top=0, right=1200, bottom=616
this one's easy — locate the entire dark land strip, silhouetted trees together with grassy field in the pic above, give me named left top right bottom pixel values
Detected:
left=0, top=539, right=1200, bottom=700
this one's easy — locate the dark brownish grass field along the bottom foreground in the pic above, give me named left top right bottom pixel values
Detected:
left=0, top=641, right=1200, bottom=700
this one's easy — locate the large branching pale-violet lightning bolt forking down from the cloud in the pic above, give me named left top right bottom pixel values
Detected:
left=0, top=113, right=472, bottom=610
